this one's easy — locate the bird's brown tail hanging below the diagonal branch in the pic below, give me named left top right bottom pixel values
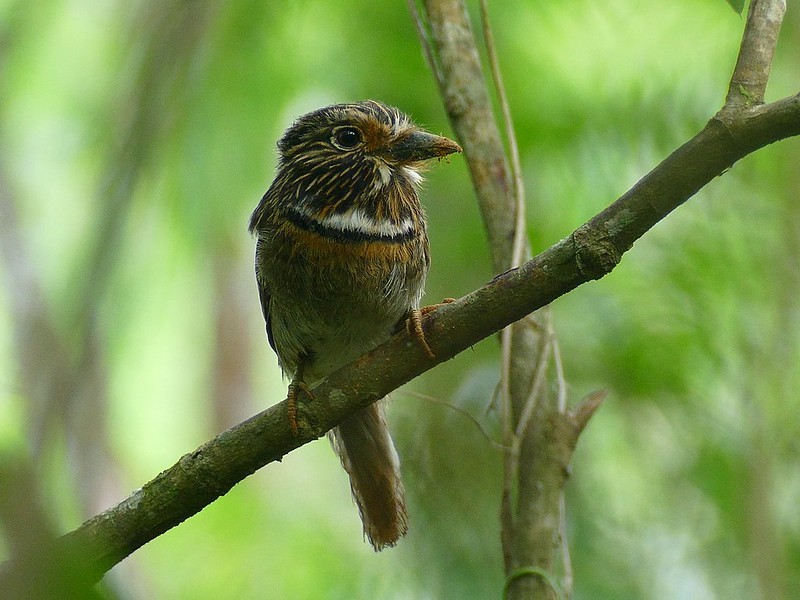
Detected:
left=330, top=403, right=408, bottom=551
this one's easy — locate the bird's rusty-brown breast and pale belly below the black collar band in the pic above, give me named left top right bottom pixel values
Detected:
left=257, top=220, right=429, bottom=383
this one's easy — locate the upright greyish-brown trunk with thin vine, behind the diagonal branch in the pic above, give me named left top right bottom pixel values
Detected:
left=418, top=0, right=574, bottom=598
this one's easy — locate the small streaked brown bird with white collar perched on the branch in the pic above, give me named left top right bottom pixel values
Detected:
left=249, top=100, right=461, bottom=551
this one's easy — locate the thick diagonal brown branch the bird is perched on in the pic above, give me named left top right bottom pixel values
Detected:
left=0, top=89, right=800, bottom=585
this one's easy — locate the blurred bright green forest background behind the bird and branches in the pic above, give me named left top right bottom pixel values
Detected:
left=0, top=0, right=800, bottom=600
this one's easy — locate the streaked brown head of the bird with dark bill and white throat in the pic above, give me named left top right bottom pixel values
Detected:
left=251, top=100, right=461, bottom=237
